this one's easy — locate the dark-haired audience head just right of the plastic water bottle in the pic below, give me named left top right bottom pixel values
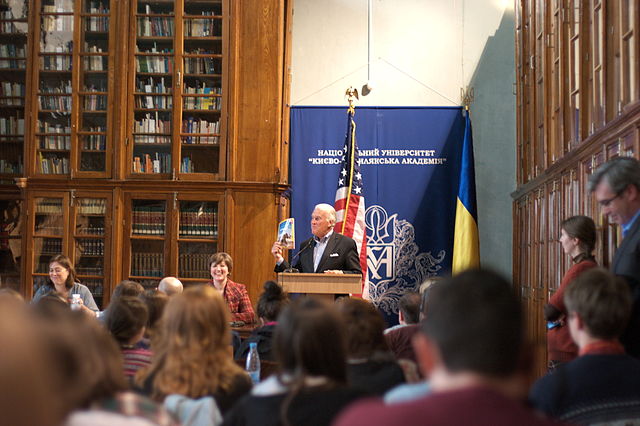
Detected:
left=274, top=297, right=347, bottom=383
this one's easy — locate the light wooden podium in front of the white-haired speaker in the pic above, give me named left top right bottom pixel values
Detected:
left=278, top=272, right=362, bottom=300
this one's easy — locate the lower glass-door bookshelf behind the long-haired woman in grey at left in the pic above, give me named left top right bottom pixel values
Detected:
left=30, top=191, right=112, bottom=307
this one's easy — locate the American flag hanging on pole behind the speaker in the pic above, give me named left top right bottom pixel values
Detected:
left=334, top=108, right=369, bottom=299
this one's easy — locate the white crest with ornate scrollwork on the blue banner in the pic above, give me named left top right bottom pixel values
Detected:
left=365, top=205, right=445, bottom=315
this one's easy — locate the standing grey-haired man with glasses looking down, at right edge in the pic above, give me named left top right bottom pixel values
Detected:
left=589, top=157, right=640, bottom=358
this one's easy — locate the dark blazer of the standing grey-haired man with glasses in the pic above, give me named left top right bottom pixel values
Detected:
left=611, top=215, right=640, bottom=358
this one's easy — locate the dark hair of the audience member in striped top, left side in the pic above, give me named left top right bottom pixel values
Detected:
left=104, top=296, right=149, bottom=345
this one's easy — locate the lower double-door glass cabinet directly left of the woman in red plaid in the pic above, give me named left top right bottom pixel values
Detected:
left=125, top=193, right=221, bottom=288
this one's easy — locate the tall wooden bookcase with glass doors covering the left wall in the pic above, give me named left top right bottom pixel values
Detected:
left=0, top=0, right=292, bottom=306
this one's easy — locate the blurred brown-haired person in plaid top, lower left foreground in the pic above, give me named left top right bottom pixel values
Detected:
left=34, top=305, right=175, bottom=426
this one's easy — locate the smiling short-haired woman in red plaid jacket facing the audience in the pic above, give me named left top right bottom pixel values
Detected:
left=209, top=252, right=255, bottom=324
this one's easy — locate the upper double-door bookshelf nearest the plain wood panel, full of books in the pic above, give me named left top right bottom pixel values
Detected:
left=128, top=0, right=225, bottom=180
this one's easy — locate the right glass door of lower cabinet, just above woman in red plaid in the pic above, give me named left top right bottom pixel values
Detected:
left=177, top=201, right=218, bottom=282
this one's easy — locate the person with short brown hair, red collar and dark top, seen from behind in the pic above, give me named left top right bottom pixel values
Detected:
left=530, top=268, right=640, bottom=425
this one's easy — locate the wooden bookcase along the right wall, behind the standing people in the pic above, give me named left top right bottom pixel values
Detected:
left=512, top=0, right=640, bottom=375
